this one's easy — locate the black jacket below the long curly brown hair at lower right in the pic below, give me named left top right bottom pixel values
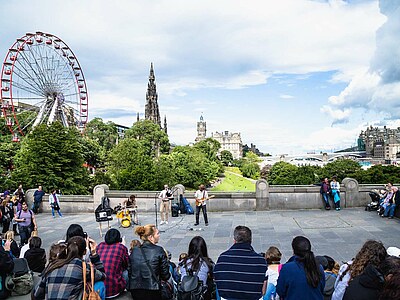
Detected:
left=343, top=265, right=385, bottom=300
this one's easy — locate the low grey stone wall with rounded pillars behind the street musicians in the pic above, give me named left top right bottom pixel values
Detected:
left=27, top=178, right=400, bottom=216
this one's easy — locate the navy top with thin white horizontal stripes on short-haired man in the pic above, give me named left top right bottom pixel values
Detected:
left=214, top=243, right=267, bottom=300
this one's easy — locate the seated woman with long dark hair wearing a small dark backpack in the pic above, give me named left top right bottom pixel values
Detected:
left=180, top=236, right=214, bottom=300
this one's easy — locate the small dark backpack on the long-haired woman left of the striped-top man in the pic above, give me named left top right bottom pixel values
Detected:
left=178, top=266, right=207, bottom=300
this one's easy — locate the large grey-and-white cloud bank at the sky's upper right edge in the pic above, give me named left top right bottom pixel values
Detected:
left=326, top=0, right=400, bottom=121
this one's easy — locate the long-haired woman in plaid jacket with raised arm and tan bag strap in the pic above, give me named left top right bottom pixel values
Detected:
left=33, top=236, right=106, bottom=300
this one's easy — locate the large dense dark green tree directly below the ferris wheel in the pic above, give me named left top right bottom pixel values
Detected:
left=12, top=122, right=88, bottom=194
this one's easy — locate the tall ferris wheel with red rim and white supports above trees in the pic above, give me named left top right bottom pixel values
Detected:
left=0, top=32, right=88, bottom=142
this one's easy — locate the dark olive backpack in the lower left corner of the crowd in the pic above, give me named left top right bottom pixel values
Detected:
left=5, top=258, right=33, bottom=296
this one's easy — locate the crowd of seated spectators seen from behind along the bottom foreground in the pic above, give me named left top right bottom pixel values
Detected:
left=0, top=219, right=400, bottom=300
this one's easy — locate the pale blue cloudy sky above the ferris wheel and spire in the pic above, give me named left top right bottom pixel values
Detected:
left=0, top=0, right=400, bottom=155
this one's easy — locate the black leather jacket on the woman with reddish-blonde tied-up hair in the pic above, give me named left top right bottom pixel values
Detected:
left=129, top=241, right=170, bottom=290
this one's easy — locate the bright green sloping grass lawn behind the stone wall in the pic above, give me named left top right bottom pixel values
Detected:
left=211, top=168, right=256, bottom=192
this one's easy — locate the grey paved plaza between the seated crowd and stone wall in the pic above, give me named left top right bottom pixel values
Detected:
left=32, top=208, right=400, bottom=262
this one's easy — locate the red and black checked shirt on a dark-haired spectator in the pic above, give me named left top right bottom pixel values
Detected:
left=97, top=242, right=129, bottom=297
